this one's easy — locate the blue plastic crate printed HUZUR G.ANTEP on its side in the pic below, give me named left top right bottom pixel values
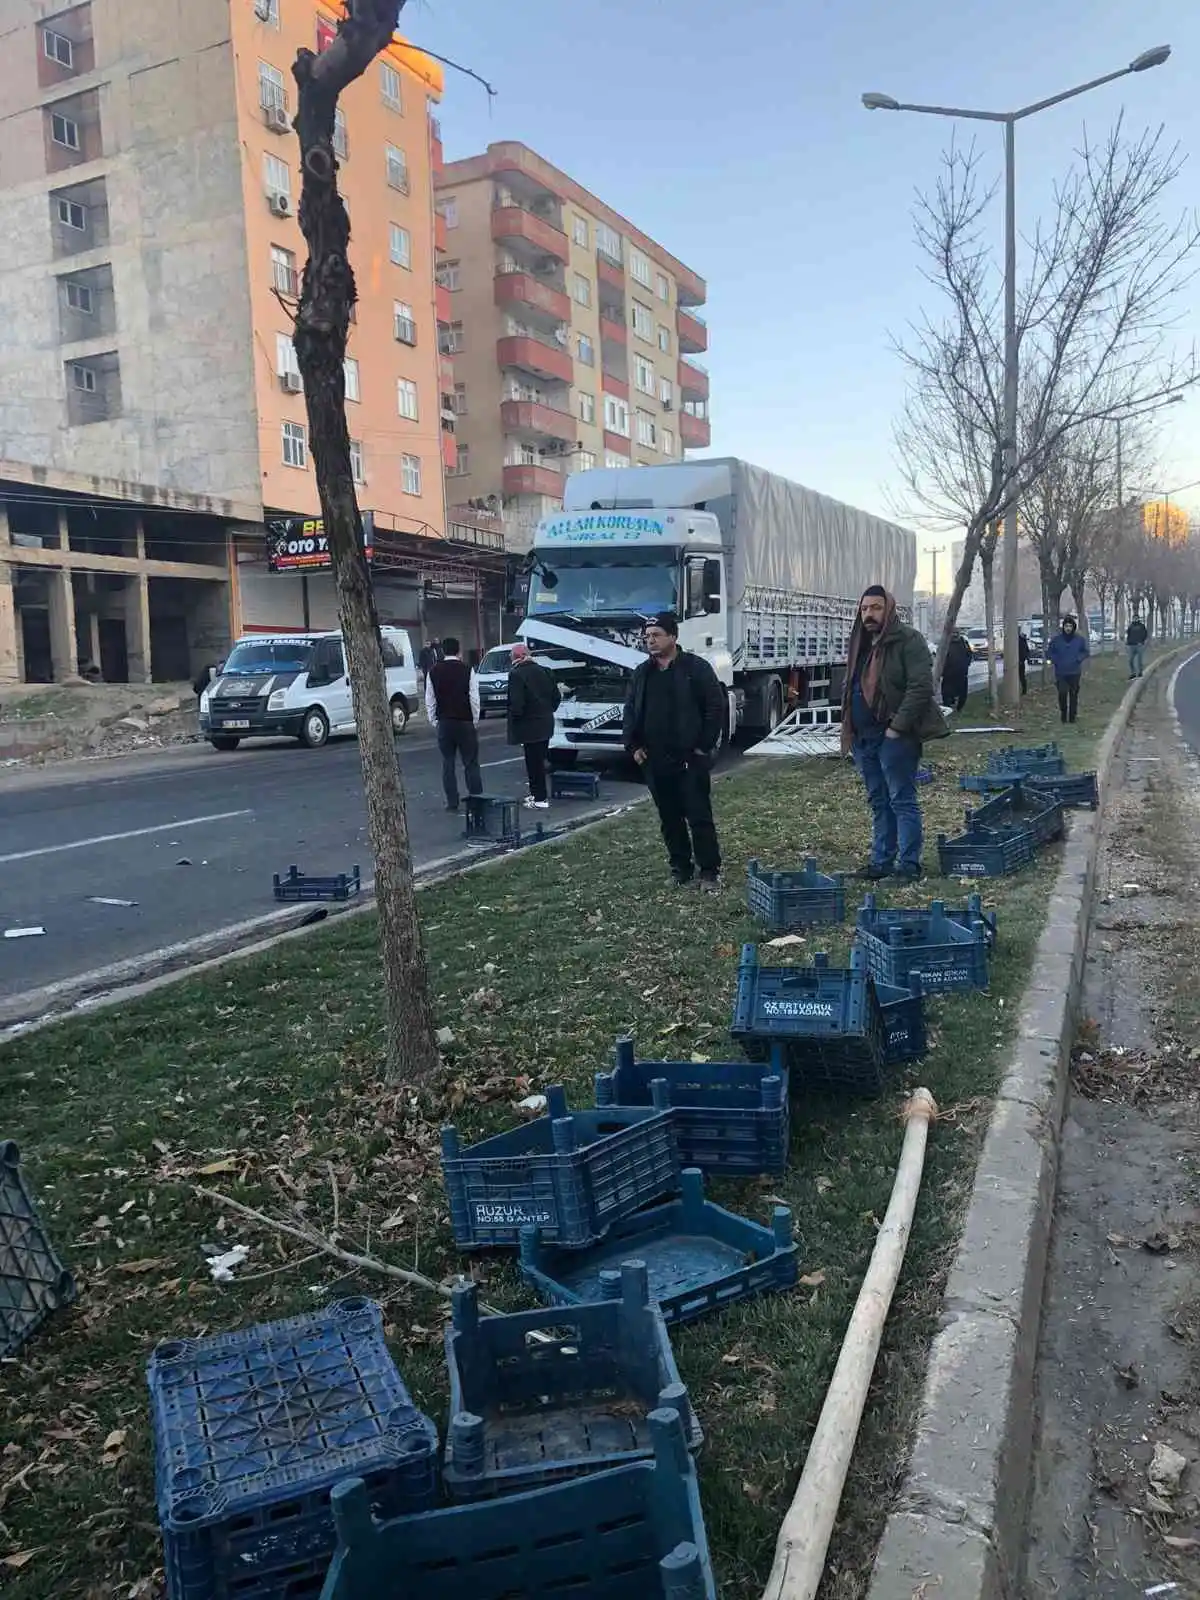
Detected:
left=442, top=1083, right=680, bottom=1250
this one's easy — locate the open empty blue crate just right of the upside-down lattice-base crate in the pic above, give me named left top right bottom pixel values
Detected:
left=442, top=1261, right=704, bottom=1499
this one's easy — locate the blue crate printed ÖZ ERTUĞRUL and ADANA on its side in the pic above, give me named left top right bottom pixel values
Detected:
left=730, top=944, right=886, bottom=1094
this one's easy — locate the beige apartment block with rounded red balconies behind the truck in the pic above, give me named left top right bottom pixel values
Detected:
left=435, top=142, right=710, bottom=550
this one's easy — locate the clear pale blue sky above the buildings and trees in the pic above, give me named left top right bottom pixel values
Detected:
left=416, top=0, right=1200, bottom=581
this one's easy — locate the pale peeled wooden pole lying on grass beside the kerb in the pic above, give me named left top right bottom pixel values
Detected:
left=763, top=1090, right=938, bottom=1600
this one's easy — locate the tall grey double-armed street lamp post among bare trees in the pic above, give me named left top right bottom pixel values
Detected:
left=862, top=45, right=1171, bottom=706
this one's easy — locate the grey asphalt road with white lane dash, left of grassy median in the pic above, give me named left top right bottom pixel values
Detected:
left=0, top=718, right=649, bottom=997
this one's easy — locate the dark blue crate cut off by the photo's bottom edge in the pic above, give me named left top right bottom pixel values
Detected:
left=320, top=1410, right=717, bottom=1600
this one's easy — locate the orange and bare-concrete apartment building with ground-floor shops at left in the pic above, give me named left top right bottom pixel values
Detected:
left=0, top=0, right=502, bottom=682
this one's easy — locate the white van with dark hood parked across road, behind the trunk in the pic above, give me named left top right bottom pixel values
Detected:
left=200, top=627, right=418, bottom=750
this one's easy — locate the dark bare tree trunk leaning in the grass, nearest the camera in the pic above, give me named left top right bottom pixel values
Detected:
left=293, top=0, right=440, bottom=1083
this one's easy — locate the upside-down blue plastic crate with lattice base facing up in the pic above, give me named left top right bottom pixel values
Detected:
left=147, top=1299, right=437, bottom=1600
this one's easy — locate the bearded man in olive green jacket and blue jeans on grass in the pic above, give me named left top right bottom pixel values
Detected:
left=842, top=584, right=949, bottom=883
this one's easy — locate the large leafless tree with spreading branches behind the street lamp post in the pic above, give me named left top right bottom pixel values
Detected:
left=896, top=122, right=1200, bottom=672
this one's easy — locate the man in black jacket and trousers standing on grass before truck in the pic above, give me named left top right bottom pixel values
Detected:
left=624, top=611, right=728, bottom=893
